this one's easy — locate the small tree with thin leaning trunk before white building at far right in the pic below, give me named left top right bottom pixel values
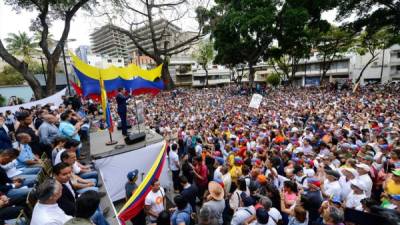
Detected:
left=354, top=29, right=393, bottom=83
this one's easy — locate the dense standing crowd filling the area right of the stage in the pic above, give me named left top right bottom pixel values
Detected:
left=121, top=84, right=400, bottom=225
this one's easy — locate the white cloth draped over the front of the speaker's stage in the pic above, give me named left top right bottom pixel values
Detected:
left=94, top=142, right=172, bottom=201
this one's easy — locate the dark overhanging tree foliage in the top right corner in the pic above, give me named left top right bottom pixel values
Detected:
left=337, top=0, right=400, bottom=43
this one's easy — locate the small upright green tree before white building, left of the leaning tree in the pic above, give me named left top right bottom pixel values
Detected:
left=314, top=26, right=353, bottom=82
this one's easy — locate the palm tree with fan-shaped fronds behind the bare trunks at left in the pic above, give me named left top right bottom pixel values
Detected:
left=5, top=32, right=38, bottom=64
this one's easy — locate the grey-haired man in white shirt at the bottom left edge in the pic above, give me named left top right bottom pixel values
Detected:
left=31, top=179, right=72, bottom=225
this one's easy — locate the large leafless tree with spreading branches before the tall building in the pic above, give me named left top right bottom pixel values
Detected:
left=107, top=0, right=203, bottom=89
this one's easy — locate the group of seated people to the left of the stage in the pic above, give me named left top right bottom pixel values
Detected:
left=0, top=96, right=109, bottom=225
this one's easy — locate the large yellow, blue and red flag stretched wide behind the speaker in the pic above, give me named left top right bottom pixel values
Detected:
left=70, top=53, right=164, bottom=97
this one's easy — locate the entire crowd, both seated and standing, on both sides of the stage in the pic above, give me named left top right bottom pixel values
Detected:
left=0, top=84, right=400, bottom=225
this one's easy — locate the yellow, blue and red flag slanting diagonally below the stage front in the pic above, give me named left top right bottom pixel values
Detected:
left=118, top=143, right=166, bottom=225
